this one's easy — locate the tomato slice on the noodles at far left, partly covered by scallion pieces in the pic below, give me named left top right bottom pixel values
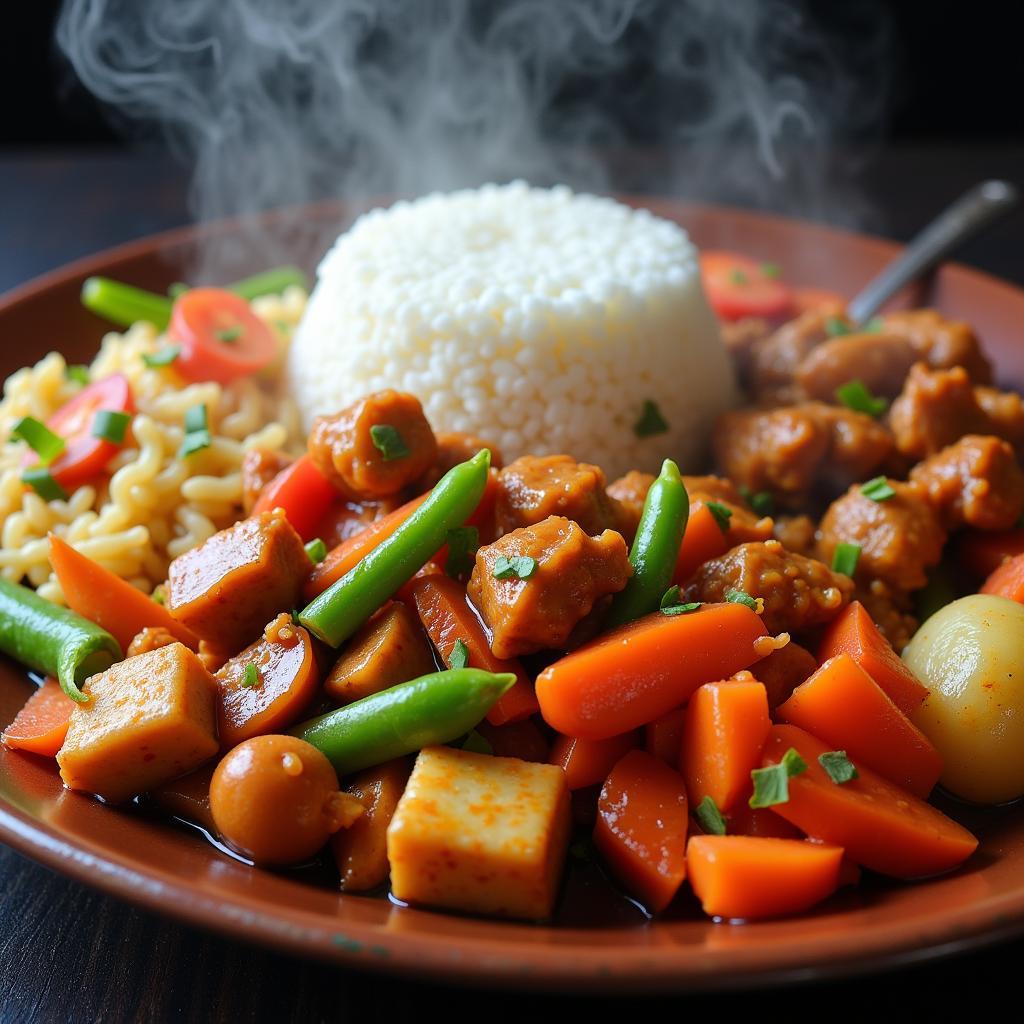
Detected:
left=24, top=374, right=135, bottom=492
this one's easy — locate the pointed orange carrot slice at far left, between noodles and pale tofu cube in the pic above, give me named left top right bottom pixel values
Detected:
left=49, top=534, right=199, bottom=650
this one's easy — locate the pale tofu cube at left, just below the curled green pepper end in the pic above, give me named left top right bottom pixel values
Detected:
left=57, top=643, right=219, bottom=803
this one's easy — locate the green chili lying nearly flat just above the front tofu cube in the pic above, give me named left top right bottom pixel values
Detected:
left=292, top=669, right=515, bottom=775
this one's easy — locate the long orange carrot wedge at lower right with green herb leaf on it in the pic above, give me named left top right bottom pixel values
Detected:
left=762, top=725, right=978, bottom=879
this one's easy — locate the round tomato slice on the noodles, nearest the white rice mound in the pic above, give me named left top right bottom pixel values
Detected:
left=167, top=288, right=278, bottom=384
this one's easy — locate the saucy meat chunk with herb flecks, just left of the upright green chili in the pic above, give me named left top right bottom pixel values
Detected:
left=468, top=516, right=633, bottom=657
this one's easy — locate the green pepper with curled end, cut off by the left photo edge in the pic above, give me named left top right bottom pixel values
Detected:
left=0, top=579, right=121, bottom=703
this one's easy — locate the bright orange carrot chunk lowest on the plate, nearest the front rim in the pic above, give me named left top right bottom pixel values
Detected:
left=686, top=836, right=843, bottom=921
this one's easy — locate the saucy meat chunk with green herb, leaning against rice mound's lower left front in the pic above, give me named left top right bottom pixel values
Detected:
left=308, top=390, right=437, bottom=501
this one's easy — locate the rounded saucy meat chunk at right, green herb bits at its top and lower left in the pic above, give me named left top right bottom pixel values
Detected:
left=818, top=480, right=946, bottom=591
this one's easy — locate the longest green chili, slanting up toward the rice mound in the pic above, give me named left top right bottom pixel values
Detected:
left=299, top=449, right=490, bottom=647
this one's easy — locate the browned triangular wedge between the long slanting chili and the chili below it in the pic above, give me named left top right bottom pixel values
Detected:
left=324, top=601, right=436, bottom=703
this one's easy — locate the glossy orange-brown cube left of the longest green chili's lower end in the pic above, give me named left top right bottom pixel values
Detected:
left=167, top=509, right=310, bottom=653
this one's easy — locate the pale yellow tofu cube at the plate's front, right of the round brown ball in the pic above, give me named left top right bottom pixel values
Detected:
left=387, top=746, right=570, bottom=921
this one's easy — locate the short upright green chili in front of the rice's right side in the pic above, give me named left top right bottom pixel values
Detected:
left=605, top=459, right=690, bottom=628
